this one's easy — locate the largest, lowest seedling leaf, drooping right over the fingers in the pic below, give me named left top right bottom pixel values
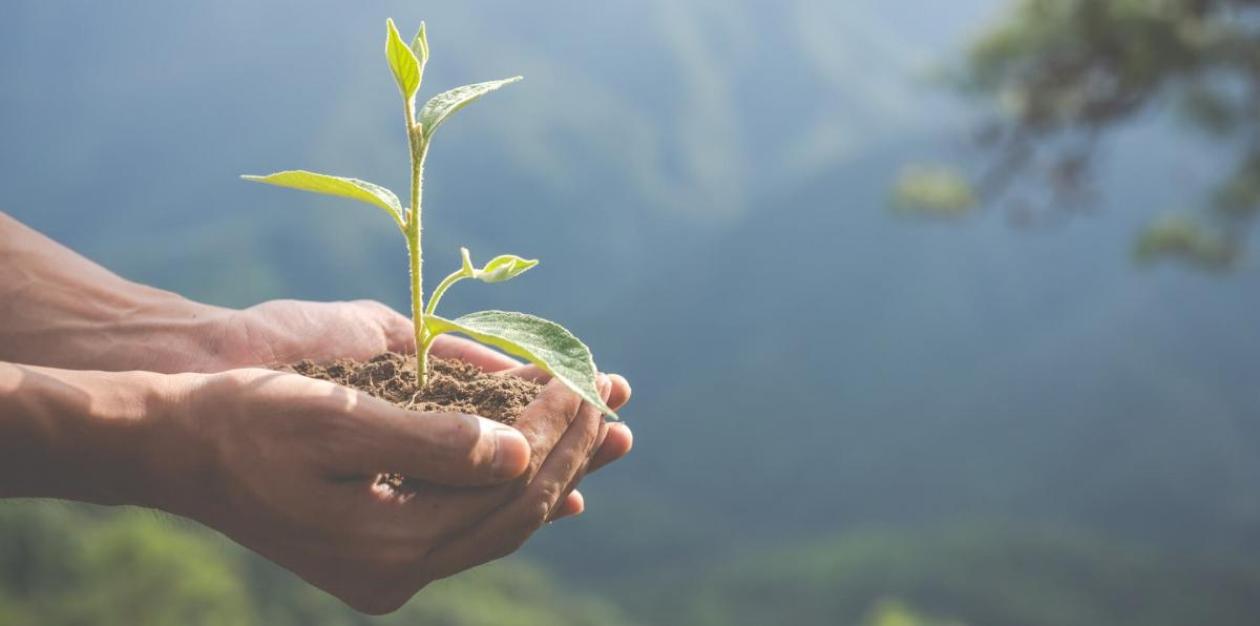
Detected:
left=425, top=311, right=620, bottom=419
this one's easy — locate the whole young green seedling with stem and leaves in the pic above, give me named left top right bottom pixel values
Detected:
left=242, top=19, right=616, bottom=417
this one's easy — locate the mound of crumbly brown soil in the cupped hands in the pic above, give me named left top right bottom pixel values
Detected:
left=281, top=353, right=542, bottom=424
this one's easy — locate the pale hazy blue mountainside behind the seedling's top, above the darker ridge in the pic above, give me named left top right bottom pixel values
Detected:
left=0, top=0, right=989, bottom=312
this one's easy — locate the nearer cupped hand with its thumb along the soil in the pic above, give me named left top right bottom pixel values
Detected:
left=154, top=362, right=629, bottom=613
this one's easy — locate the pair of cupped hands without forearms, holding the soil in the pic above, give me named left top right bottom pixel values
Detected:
left=103, top=300, right=631, bottom=613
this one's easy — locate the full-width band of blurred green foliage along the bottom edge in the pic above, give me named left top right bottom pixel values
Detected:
left=7, top=501, right=1260, bottom=626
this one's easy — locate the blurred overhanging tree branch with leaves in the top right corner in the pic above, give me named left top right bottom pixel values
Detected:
left=956, top=0, right=1260, bottom=270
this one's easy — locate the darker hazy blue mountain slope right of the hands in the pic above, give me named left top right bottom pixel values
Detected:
left=547, top=127, right=1260, bottom=581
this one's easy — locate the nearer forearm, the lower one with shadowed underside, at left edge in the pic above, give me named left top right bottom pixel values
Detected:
left=0, top=363, right=189, bottom=508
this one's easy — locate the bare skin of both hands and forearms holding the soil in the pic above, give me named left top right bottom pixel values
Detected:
left=0, top=213, right=633, bottom=613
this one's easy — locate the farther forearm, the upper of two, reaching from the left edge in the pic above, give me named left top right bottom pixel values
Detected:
left=0, top=213, right=227, bottom=372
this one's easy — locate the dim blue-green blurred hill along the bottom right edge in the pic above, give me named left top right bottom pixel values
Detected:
left=636, top=524, right=1260, bottom=626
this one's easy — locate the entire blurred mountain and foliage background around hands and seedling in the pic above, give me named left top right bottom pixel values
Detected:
left=0, top=0, right=1260, bottom=626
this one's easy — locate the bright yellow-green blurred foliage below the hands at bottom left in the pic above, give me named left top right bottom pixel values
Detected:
left=0, top=501, right=640, bottom=626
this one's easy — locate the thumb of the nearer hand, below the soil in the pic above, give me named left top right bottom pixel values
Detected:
left=343, top=402, right=530, bottom=486
